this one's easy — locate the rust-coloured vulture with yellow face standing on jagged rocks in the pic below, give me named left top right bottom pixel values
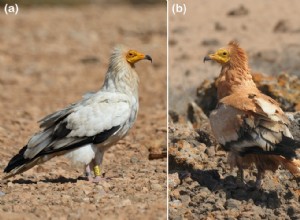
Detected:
left=204, top=41, right=300, bottom=187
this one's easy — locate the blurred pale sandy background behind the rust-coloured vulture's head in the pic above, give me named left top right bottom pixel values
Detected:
left=169, top=0, right=300, bottom=113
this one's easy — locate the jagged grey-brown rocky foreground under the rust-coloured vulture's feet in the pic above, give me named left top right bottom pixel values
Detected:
left=168, top=88, right=300, bottom=219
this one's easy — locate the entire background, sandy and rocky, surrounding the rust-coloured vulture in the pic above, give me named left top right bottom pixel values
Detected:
left=168, top=0, right=300, bottom=219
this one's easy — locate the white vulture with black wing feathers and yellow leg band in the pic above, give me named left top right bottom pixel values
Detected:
left=4, top=46, right=152, bottom=182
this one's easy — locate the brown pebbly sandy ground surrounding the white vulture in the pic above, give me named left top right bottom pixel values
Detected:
left=0, top=4, right=167, bottom=219
